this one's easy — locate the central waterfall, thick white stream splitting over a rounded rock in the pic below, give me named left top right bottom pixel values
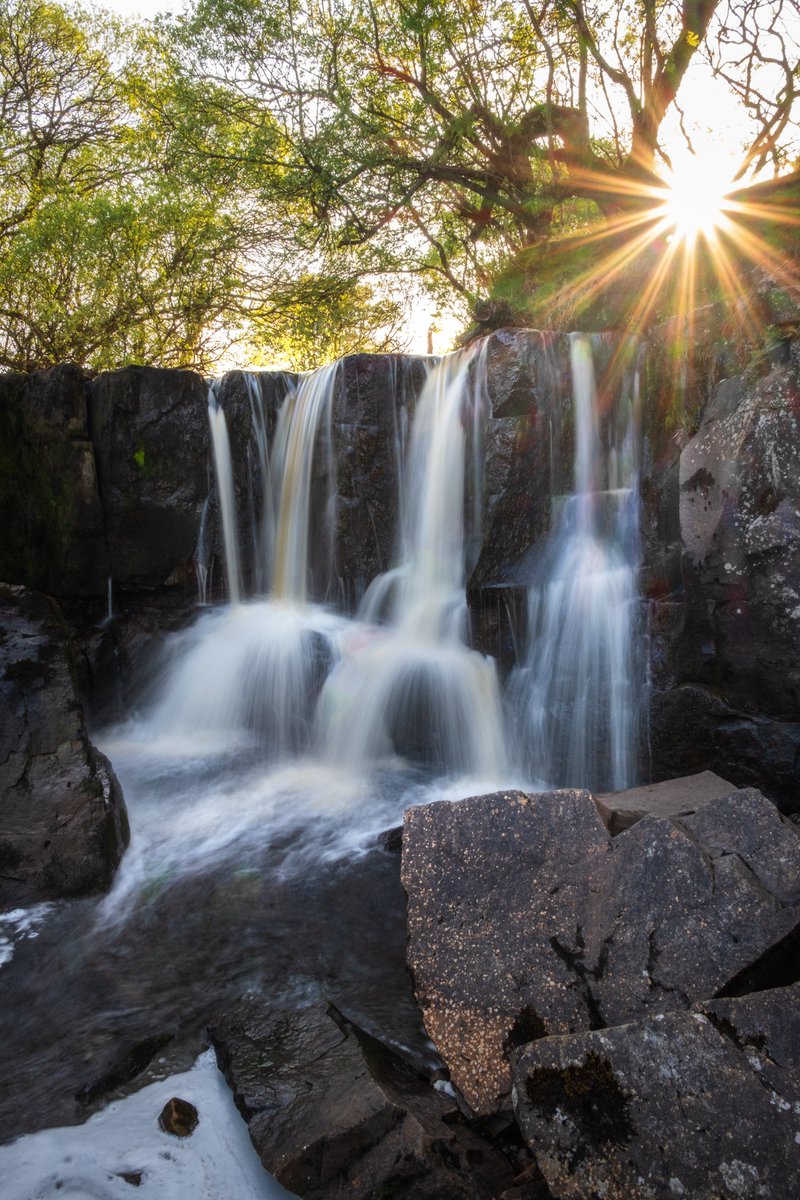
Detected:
left=319, top=350, right=505, bottom=776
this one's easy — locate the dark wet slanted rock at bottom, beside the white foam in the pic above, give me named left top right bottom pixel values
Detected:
left=209, top=1001, right=511, bottom=1200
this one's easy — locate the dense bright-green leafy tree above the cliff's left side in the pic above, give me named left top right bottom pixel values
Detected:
left=0, top=0, right=407, bottom=370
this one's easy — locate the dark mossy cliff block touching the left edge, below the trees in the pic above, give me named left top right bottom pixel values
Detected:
left=0, top=365, right=109, bottom=598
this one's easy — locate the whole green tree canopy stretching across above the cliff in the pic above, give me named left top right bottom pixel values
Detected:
left=0, top=0, right=800, bottom=367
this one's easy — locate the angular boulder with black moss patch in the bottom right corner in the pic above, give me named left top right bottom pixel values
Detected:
left=512, top=986, right=800, bottom=1200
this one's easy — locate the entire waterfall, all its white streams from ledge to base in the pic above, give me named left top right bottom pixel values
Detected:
left=149, top=335, right=642, bottom=790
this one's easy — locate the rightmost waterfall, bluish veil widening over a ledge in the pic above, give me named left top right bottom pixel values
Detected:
left=506, top=334, right=643, bottom=791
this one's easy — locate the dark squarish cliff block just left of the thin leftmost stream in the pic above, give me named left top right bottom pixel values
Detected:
left=89, top=367, right=211, bottom=596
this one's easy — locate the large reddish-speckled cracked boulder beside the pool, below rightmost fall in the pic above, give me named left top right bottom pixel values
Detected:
left=402, top=791, right=800, bottom=1114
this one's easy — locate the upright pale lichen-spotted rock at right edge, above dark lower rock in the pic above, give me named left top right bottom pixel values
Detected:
left=680, top=352, right=800, bottom=721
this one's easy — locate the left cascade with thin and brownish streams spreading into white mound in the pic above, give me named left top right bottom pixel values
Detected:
left=146, top=364, right=342, bottom=760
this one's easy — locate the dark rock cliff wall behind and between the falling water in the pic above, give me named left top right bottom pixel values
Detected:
left=0, top=329, right=800, bottom=810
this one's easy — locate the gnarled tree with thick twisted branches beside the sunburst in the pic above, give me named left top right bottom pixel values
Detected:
left=179, top=0, right=799, bottom=328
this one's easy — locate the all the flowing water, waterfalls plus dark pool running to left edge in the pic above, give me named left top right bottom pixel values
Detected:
left=0, top=336, right=639, bottom=1200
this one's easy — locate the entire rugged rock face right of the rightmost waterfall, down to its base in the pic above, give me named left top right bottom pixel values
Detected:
left=650, top=342, right=800, bottom=811
